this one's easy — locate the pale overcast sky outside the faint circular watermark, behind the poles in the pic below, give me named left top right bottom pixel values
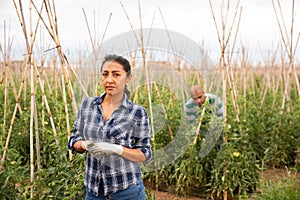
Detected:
left=0, top=0, right=300, bottom=62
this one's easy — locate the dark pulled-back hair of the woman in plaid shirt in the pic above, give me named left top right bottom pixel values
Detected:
left=101, top=54, right=131, bottom=98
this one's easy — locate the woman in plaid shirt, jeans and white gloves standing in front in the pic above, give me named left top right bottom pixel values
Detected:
left=68, top=55, right=152, bottom=200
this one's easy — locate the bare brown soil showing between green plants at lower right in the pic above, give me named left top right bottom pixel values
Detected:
left=147, top=169, right=300, bottom=200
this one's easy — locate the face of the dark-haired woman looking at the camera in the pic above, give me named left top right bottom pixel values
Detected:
left=102, top=61, right=129, bottom=96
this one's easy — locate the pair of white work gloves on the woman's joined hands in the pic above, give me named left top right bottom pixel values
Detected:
left=83, top=141, right=123, bottom=157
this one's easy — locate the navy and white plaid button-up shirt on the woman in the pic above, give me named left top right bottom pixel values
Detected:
left=68, top=93, right=152, bottom=196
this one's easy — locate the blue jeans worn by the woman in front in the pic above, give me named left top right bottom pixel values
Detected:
left=85, top=179, right=146, bottom=200
